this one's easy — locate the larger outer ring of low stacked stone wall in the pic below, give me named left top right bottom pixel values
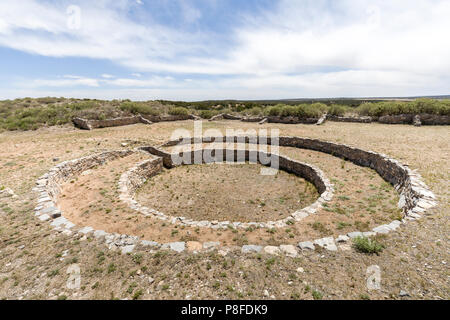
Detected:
left=33, top=137, right=437, bottom=257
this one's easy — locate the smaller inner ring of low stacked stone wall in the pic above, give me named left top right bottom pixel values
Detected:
left=118, top=147, right=334, bottom=229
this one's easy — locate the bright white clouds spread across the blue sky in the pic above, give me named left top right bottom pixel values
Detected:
left=0, top=0, right=450, bottom=99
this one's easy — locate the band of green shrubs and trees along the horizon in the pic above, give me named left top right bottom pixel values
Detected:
left=0, top=97, right=450, bottom=130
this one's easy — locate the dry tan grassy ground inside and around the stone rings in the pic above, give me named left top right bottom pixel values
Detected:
left=0, top=121, right=450, bottom=300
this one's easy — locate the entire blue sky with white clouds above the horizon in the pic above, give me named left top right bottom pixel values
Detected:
left=0, top=0, right=450, bottom=100
